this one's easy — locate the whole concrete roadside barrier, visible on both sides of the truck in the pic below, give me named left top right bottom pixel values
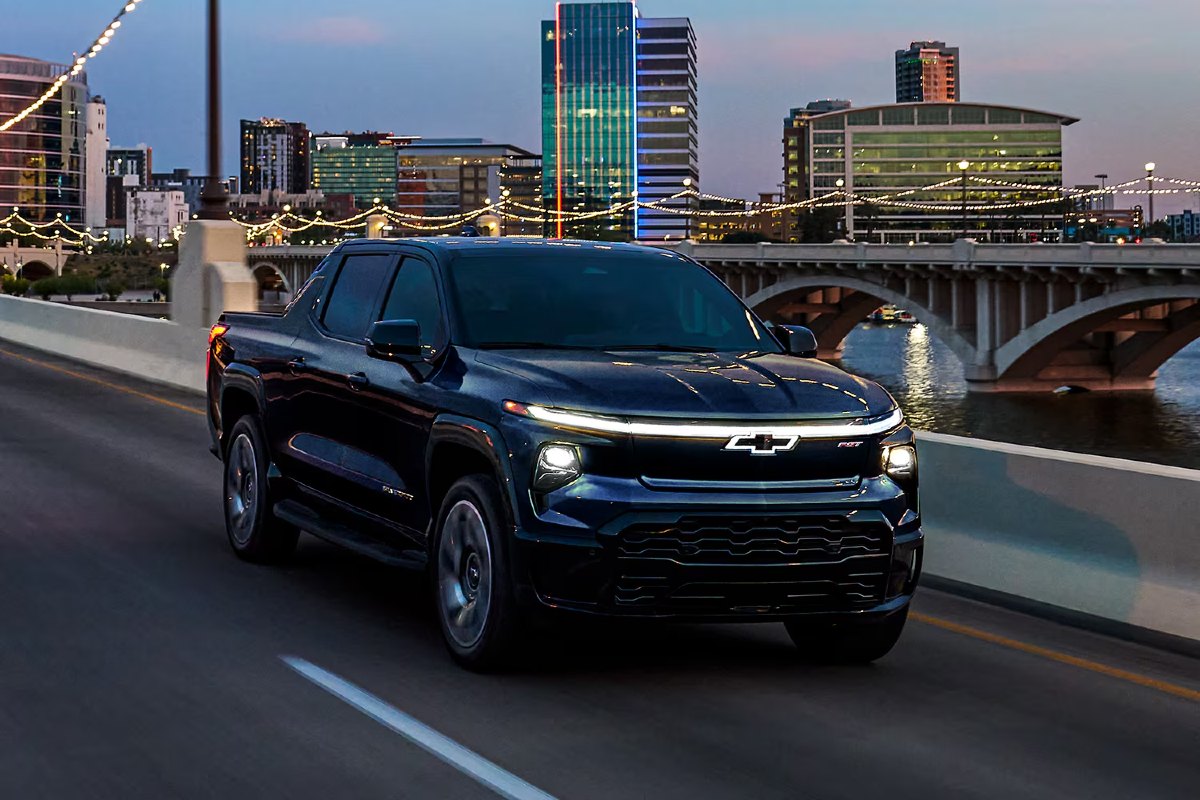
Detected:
left=0, top=296, right=1200, bottom=642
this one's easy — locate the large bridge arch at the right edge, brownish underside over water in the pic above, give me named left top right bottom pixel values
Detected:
left=995, top=284, right=1200, bottom=390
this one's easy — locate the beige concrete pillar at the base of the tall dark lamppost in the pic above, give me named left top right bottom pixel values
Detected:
left=170, top=219, right=258, bottom=329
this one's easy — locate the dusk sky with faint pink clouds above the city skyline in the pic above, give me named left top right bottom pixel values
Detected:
left=16, top=0, right=1200, bottom=210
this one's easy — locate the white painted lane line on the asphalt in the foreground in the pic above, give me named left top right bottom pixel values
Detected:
left=280, top=656, right=556, bottom=800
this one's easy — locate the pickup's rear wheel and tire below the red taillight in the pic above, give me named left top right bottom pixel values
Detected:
left=223, top=414, right=300, bottom=564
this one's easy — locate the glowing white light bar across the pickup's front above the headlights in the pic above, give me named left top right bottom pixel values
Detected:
left=504, top=401, right=904, bottom=440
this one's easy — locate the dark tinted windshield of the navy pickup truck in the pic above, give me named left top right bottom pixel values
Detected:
left=448, top=247, right=779, bottom=353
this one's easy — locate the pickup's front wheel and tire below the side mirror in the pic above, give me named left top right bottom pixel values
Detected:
left=430, top=475, right=522, bottom=672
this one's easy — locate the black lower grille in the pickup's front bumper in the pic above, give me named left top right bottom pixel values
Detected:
left=612, top=516, right=892, bottom=614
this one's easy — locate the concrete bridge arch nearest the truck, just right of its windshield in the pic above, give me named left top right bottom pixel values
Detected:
left=745, top=275, right=976, bottom=366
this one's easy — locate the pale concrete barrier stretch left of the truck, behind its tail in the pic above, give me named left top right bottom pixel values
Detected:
left=0, top=296, right=208, bottom=391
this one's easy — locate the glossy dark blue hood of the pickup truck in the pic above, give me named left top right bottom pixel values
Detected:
left=475, top=350, right=895, bottom=421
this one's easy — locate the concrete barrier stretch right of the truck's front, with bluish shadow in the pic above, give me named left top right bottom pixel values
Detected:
left=918, top=433, right=1200, bottom=640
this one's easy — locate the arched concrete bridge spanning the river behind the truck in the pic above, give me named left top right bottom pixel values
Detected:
left=247, top=240, right=1200, bottom=391
